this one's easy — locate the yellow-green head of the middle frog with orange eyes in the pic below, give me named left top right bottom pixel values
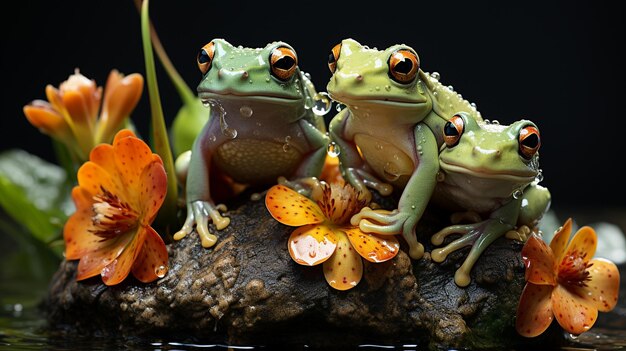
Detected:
left=327, top=39, right=432, bottom=115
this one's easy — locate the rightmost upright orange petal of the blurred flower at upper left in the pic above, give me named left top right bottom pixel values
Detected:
left=98, top=70, right=143, bottom=143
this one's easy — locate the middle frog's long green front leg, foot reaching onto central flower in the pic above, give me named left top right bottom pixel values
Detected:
left=350, top=124, right=439, bottom=259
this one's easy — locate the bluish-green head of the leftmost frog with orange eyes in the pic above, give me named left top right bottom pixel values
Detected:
left=197, top=39, right=304, bottom=106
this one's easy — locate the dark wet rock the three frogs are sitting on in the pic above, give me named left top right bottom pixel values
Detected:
left=43, top=195, right=562, bottom=349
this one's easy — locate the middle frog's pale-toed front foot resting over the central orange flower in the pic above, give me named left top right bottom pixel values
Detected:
left=350, top=207, right=424, bottom=259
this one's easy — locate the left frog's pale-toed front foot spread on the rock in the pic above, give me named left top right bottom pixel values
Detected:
left=174, top=200, right=230, bottom=248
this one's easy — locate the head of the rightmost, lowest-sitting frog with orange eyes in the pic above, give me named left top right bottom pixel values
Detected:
left=439, top=113, right=541, bottom=201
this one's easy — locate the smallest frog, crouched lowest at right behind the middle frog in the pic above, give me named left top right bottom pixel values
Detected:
left=430, top=112, right=551, bottom=287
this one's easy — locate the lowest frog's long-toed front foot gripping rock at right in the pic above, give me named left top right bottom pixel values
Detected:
left=430, top=218, right=513, bottom=287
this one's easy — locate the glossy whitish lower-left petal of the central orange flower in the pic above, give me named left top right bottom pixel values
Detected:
left=288, top=224, right=337, bottom=266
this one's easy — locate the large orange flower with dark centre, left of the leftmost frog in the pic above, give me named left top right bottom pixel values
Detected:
left=63, top=129, right=168, bottom=285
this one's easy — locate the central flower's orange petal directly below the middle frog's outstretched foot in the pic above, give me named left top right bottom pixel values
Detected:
left=343, top=228, right=400, bottom=262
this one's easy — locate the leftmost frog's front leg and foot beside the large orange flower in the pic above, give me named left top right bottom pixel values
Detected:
left=174, top=125, right=230, bottom=248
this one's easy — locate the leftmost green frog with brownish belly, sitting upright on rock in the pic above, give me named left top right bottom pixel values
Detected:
left=173, top=38, right=330, bottom=248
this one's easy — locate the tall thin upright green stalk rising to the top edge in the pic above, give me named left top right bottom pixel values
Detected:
left=141, top=0, right=178, bottom=239
